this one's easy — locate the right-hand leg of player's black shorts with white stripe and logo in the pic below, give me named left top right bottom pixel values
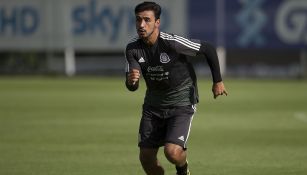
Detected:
left=165, top=105, right=195, bottom=149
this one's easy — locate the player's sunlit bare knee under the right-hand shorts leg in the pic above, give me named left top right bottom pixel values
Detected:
left=164, top=144, right=185, bottom=164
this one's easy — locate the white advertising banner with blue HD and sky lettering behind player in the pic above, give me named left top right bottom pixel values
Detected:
left=0, top=0, right=187, bottom=51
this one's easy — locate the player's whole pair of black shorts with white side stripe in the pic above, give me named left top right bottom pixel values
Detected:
left=138, top=104, right=196, bottom=149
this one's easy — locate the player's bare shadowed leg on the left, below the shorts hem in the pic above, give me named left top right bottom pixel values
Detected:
left=139, top=148, right=164, bottom=175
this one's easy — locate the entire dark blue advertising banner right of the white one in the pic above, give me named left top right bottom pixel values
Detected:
left=189, top=0, right=307, bottom=48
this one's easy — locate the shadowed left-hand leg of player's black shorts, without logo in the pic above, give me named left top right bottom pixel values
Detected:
left=138, top=105, right=166, bottom=148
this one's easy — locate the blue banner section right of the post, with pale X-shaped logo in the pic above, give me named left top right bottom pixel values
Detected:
left=225, top=0, right=307, bottom=48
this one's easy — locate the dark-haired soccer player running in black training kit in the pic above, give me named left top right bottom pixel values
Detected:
left=125, top=2, right=227, bottom=175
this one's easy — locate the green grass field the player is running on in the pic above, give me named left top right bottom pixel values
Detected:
left=0, top=77, right=307, bottom=175
